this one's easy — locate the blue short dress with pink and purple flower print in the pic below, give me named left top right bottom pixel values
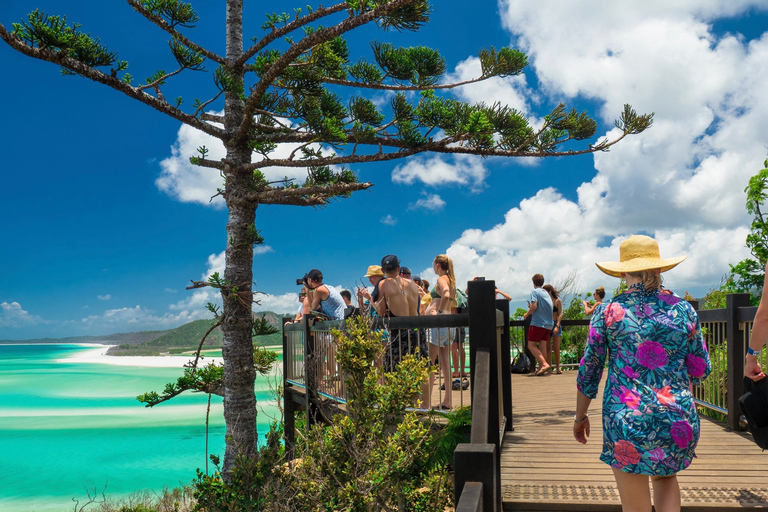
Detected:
left=577, top=290, right=712, bottom=476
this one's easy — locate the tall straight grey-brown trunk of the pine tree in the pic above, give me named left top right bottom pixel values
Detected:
left=222, top=0, right=257, bottom=478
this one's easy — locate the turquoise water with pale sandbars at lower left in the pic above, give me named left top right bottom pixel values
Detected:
left=0, top=345, right=277, bottom=512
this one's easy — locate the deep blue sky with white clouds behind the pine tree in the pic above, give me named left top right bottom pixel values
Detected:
left=0, top=0, right=768, bottom=340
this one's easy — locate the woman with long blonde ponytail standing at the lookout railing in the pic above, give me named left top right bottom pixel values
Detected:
left=426, top=254, right=461, bottom=410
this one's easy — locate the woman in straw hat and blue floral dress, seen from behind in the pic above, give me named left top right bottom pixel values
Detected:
left=573, top=235, right=711, bottom=512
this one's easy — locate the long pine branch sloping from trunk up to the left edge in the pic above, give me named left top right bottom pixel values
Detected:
left=0, top=24, right=226, bottom=140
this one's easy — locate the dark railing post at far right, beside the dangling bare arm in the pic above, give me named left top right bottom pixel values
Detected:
left=725, top=293, right=749, bottom=430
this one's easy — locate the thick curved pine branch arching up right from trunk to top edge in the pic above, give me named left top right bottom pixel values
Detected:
left=242, top=0, right=413, bottom=144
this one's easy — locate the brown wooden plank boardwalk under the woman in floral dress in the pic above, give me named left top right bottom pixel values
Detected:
left=501, top=371, right=768, bottom=512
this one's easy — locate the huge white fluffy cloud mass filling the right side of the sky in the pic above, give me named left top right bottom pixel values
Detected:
left=424, top=0, right=768, bottom=300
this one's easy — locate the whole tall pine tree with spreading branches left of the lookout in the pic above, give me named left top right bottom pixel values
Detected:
left=0, top=0, right=653, bottom=475
